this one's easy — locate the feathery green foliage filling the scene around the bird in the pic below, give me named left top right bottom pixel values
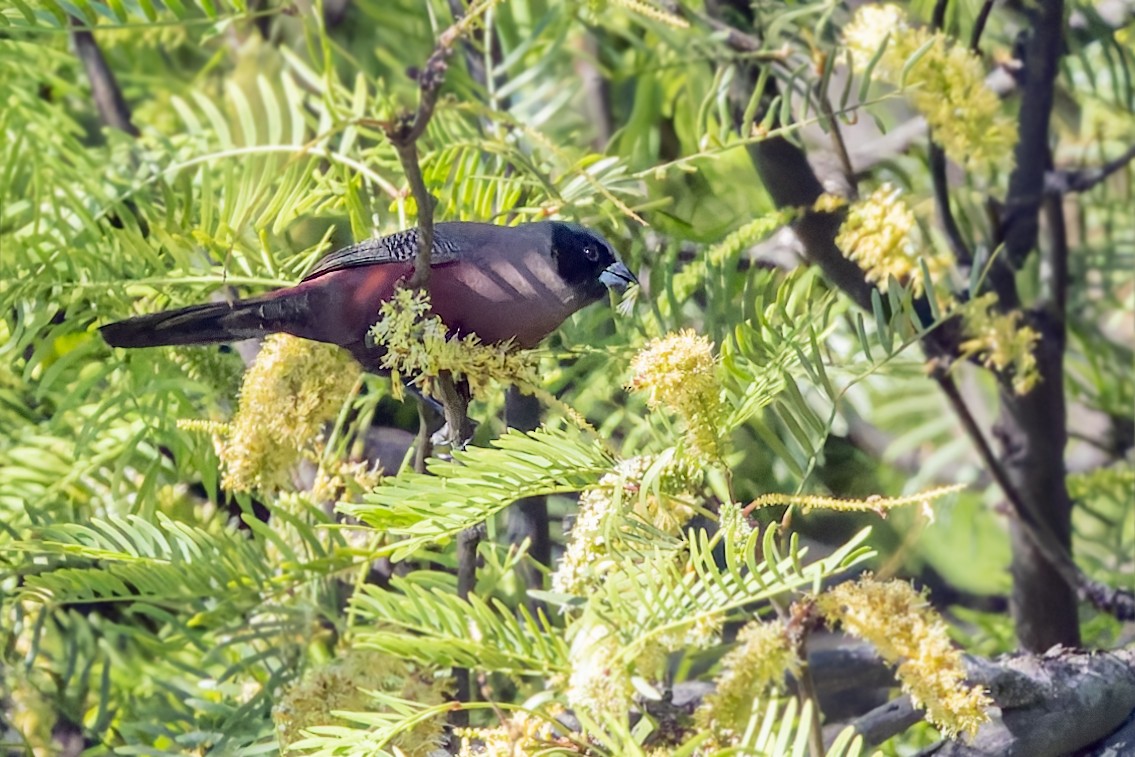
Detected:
left=0, top=0, right=1135, bottom=757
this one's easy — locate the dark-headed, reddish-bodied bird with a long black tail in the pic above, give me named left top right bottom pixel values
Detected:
left=99, top=221, right=638, bottom=372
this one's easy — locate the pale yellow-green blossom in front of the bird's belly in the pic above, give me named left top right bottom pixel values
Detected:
left=371, top=288, right=538, bottom=395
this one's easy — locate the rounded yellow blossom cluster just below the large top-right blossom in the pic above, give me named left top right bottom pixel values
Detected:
left=835, top=184, right=948, bottom=294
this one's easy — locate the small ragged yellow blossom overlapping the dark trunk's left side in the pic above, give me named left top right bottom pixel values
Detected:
left=958, top=293, right=1041, bottom=394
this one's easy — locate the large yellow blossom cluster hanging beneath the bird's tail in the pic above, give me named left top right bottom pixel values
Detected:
left=179, top=334, right=360, bottom=491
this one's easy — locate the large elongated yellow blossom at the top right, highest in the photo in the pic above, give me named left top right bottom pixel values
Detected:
left=843, top=5, right=1017, bottom=168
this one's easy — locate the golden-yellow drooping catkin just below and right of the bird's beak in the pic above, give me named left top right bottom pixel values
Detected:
left=627, top=329, right=726, bottom=457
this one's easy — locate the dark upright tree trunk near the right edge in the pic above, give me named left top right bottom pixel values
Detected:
left=993, top=0, right=1079, bottom=651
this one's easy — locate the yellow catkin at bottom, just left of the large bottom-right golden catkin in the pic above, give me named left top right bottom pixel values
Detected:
left=695, top=621, right=799, bottom=742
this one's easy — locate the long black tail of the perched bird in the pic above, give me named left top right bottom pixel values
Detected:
left=99, top=295, right=292, bottom=347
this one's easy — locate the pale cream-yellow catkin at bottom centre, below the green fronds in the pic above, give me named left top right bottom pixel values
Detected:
left=566, top=621, right=634, bottom=720
